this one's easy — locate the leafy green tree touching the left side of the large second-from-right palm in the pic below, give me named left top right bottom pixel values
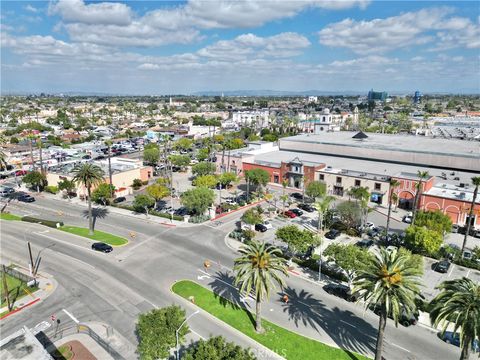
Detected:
left=323, top=243, right=373, bottom=286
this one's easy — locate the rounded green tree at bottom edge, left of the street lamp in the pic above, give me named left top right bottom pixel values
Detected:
left=136, top=305, right=190, bottom=360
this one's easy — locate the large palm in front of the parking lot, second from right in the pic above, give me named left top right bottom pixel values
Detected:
left=353, top=249, right=421, bottom=360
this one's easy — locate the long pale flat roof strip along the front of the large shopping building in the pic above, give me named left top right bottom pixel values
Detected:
left=255, top=150, right=473, bottom=188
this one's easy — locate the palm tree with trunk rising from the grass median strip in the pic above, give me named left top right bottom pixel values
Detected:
left=233, top=241, right=288, bottom=333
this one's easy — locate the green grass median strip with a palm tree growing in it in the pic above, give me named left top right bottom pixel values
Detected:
left=172, top=280, right=368, bottom=360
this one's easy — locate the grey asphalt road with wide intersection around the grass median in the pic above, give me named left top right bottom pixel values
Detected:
left=0, top=198, right=459, bottom=360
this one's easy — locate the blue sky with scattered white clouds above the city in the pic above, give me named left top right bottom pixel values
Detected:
left=0, top=0, right=480, bottom=95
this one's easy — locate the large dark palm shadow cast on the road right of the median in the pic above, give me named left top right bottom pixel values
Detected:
left=279, top=287, right=377, bottom=359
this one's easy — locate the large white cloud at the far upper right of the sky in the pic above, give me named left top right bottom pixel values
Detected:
left=318, top=7, right=480, bottom=54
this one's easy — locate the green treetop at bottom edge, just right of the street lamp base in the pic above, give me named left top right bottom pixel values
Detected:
left=184, top=336, right=256, bottom=360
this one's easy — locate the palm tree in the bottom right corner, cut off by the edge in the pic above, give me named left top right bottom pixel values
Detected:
left=430, top=277, right=480, bottom=360
